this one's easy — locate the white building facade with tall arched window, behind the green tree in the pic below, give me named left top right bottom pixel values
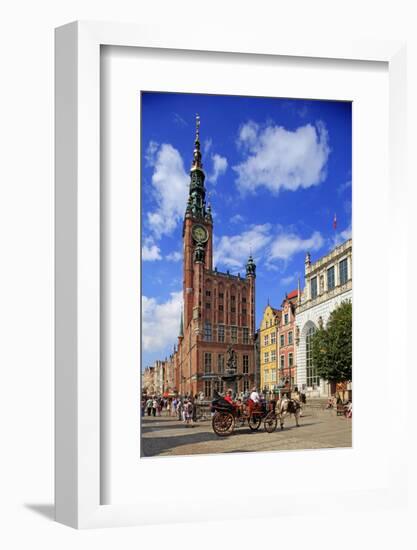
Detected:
left=296, top=239, right=352, bottom=397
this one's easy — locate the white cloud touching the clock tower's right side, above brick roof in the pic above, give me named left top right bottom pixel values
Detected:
left=214, top=223, right=272, bottom=271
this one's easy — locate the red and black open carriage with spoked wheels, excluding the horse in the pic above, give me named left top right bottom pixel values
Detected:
left=211, top=394, right=278, bottom=436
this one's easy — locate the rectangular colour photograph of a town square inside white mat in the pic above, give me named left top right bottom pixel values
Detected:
left=138, top=91, right=353, bottom=458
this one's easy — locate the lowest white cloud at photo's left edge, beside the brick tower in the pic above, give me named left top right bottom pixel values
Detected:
left=142, top=291, right=182, bottom=352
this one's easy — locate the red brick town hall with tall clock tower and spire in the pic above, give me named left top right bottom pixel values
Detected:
left=173, top=118, right=256, bottom=398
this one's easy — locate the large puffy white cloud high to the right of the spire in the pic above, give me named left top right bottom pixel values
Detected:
left=233, top=121, right=330, bottom=193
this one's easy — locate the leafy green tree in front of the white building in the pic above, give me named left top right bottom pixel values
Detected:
left=312, top=301, right=352, bottom=382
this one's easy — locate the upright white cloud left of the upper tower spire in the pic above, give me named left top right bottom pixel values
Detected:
left=148, top=143, right=189, bottom=238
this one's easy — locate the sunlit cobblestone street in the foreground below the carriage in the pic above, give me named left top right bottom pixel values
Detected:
left=142, top=408, right=352, bottom=457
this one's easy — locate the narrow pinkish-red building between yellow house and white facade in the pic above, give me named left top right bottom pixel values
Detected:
left=278, top=290, right=299, bottom=388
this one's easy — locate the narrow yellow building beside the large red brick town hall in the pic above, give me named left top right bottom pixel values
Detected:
left=260, top=304, right=282, bottom=392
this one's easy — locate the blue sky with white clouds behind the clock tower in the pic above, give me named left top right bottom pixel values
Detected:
left=141, top=92, right=352, bottom=367
